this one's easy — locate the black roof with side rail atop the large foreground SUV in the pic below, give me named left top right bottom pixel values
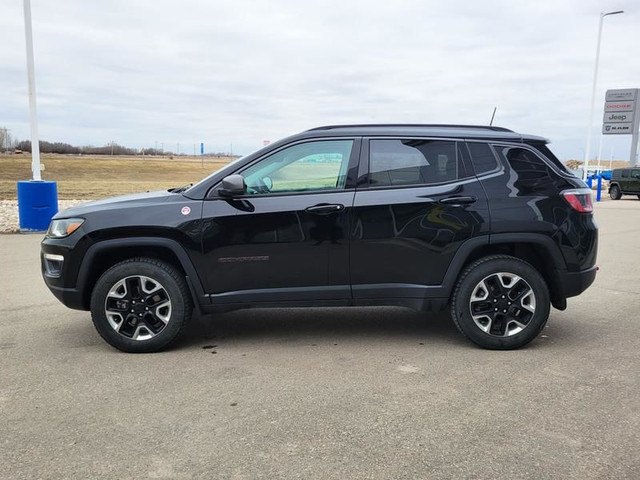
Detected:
left=295, top=123, right=548, bottom=143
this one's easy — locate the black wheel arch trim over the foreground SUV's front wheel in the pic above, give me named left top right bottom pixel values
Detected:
left=76, top=237, right=208, bottom=309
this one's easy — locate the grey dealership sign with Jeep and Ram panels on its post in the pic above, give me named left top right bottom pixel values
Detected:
left=602, top=88, right=640, bottom=167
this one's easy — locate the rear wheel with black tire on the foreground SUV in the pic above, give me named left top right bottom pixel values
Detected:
left=451, top=255, right=551, bottom=350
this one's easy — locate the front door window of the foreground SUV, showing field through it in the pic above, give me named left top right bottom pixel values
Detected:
left=242, top=140, right=353, bottom=195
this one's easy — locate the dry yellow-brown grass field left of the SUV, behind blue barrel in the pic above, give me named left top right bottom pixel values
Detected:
left=0, top=154, right=232, bottom=200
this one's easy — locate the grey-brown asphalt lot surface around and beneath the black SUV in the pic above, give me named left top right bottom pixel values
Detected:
left=0, top=199, right=640, bottom=480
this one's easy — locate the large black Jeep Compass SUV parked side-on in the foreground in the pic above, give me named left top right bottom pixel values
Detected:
left=41, top=125, right=598, bottom=352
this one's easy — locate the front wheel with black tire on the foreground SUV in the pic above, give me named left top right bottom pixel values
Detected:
left=91, top=258, right=193, bottom=353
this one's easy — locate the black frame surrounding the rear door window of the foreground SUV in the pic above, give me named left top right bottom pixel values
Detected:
left=356, top=135, right=474, bottom=190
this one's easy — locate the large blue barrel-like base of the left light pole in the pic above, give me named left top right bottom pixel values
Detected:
left=18, top=180, right=58, bottom=232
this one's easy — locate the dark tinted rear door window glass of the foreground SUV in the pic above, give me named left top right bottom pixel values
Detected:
left=369, top=140, right=461, bottom=187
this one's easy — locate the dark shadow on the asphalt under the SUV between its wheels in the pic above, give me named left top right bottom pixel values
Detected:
left=174, top=307, right=469, bottom=349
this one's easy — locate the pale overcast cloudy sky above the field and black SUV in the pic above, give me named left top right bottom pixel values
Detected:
left=0, top=0, right=640, bottom=160
